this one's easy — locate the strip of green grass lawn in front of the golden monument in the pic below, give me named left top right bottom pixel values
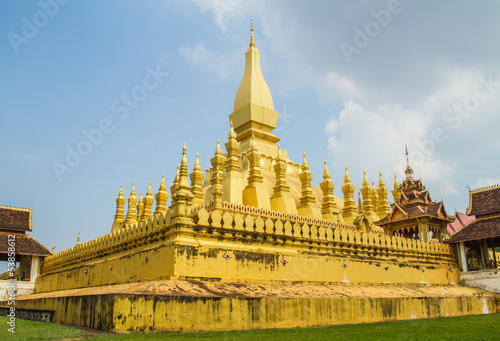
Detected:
left=0, top=314, right=500, bottom=341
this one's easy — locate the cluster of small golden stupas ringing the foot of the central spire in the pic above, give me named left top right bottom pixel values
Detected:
left=111, top=137, right=397, bottom=232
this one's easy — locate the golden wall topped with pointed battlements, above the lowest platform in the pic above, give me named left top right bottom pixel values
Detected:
left=35, top=209, right=460, bottom=293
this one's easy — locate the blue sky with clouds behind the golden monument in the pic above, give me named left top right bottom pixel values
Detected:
left=0, top=0, right=500, bottom=255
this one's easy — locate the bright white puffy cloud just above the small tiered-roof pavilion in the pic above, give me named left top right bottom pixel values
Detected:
left=325, top=101, right=458, bottom=195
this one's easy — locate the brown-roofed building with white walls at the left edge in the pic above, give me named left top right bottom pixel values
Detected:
left=0, top=206, right=52, bottom=300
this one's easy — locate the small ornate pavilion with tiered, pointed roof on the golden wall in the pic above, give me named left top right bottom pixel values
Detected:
left=375, top=152, right=453, bottom=242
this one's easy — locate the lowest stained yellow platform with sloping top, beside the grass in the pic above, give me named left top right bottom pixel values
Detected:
left=3, top=280, right=496, bottom=333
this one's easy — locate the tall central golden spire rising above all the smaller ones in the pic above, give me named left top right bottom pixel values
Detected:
left=229, top=21, right=280, bottom=154
